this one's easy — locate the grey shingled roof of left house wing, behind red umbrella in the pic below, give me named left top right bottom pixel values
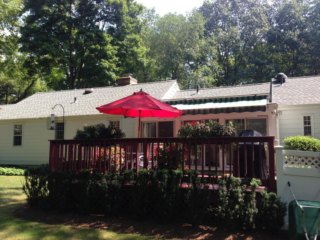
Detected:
left=0, top=80, right=179, bottom=120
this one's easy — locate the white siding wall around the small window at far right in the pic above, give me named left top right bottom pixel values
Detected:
left=278, top=105, right=320, bottom=143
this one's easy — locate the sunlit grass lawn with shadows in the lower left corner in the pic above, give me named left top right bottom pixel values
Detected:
left=0, top=176, right=154, bottom=240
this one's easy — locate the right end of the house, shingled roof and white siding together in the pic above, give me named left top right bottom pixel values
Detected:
left=272, top=76, right=320, bottom=143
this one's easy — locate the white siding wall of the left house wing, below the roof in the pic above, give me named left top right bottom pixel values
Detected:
left=0, top=114, right=136, bottom=165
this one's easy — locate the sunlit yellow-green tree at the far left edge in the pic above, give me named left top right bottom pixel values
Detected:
left=0, top=0, right=46, bottom=104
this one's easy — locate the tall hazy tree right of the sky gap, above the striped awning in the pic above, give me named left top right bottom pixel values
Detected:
left=199, top=0, right=269, bottom=85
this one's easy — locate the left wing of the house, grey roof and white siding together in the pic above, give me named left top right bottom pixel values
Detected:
left=0, top=77, right=179, bottom=165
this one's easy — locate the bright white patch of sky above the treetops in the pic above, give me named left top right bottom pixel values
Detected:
left=136, top=0, right=204, bottom=16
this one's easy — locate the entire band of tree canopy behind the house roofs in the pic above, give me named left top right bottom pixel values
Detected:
left=0, top=0, right=320, bottom=104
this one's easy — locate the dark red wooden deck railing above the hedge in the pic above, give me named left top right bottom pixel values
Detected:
left=49, top=136, right=276, bottom=191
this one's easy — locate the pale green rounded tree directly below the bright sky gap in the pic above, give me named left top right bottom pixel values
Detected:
left=140, top=12, right=210, bottom=88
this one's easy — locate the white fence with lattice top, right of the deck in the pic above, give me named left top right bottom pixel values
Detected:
left=275, top=146, right=320, bottom=229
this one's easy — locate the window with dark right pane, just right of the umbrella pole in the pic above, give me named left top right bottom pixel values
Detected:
left=142, top=122, right=173, bottom=138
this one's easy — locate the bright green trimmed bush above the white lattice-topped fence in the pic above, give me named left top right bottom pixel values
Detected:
left=284, top=136, right=320, bottom=152
